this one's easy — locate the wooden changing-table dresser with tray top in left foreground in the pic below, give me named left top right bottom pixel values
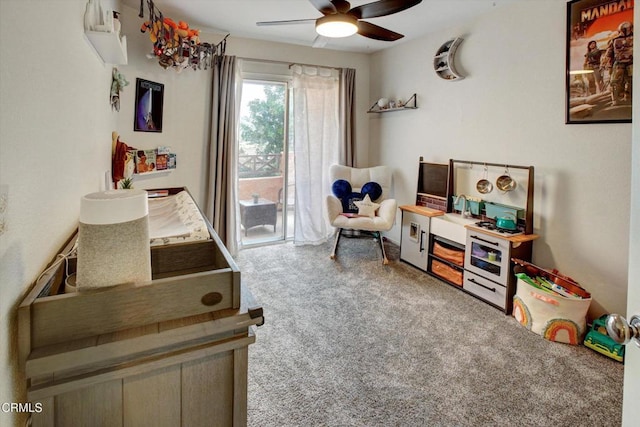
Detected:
left=18, top=222, right=264, bottom=427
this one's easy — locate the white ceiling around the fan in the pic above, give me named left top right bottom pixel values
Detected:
left=122, top=0, right=524, bottom=53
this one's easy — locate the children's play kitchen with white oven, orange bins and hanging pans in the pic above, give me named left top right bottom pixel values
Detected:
left=400, top=158, right=538, bottom=314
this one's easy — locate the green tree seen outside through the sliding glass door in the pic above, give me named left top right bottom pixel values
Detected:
left=240, top=85, right=285, bottom=154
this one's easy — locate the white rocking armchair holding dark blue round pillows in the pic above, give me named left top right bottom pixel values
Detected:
left=326, top=165, right=398, bottom=264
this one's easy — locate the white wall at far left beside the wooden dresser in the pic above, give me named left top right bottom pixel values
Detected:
left=0, top=0, right=115, bottom=425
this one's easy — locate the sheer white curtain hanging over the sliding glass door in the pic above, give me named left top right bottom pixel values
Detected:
left=291, top=65, right=341, bottom=245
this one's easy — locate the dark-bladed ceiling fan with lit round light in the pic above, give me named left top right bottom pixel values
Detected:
left=256, top=0, right=422, bottom=45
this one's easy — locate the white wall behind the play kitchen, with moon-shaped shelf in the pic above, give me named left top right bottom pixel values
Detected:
left=370, top=0, right=631, bottom=318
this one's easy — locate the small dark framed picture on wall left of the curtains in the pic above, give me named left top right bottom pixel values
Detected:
left=133, top=79, right=164, bottom=132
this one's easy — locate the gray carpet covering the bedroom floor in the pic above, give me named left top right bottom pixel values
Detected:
left=237, top=238, right=624, bottom=427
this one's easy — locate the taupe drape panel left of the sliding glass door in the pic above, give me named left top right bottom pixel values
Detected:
left=205, top=56, right=240, bottom=254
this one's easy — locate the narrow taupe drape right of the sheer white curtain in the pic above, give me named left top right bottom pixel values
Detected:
left=340, top=68, right=356, bottom=167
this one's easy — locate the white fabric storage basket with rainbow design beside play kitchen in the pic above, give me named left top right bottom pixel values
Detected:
left=513, top=278, right=591, bottom=345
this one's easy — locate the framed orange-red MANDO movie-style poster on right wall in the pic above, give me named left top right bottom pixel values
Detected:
left=566, top=0, right=634, bottom=124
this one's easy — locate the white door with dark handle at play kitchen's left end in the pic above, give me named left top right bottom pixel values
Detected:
left=400, top=211, right=429, bottom=271
